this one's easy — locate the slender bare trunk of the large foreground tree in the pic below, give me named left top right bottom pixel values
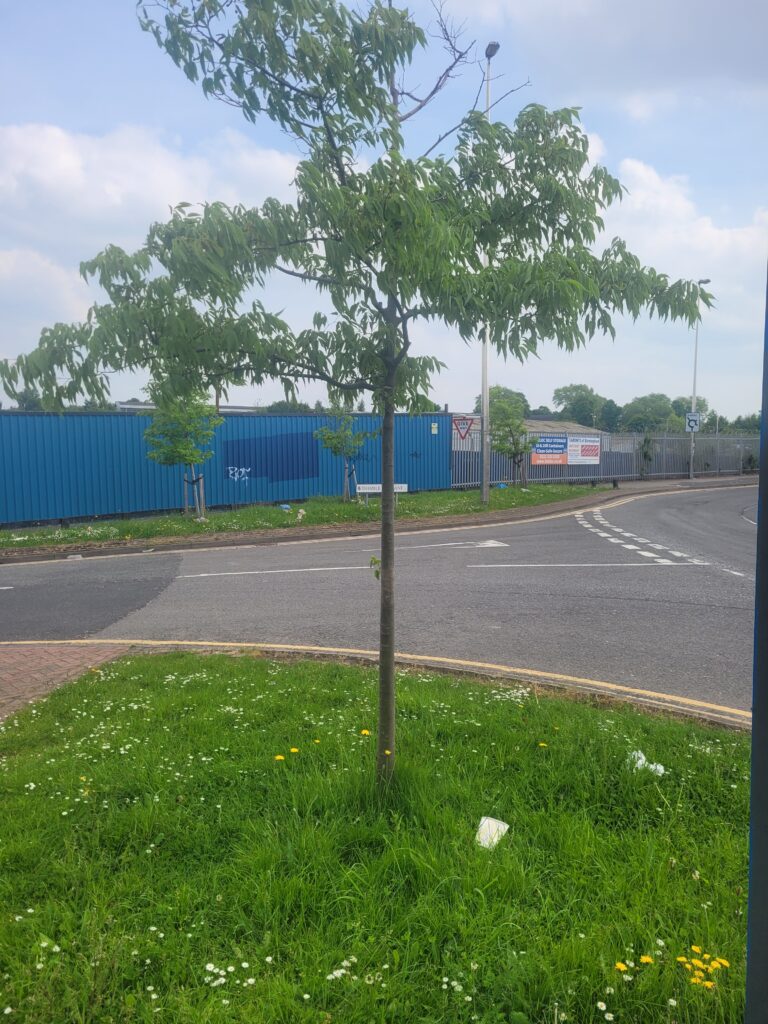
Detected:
left=376, top=381, right=395, bottom=783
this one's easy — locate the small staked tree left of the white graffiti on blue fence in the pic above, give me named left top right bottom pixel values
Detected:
left=144, top=383, right=224, bottom=519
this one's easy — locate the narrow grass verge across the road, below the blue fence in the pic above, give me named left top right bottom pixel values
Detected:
left=0, top=483, right=608, bottom=550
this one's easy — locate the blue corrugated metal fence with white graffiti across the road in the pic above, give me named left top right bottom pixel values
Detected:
left=0, top=412, right=452, bottom=523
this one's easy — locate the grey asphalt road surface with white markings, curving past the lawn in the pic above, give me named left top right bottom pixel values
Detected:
left=0, top=486, right=757, bottom=709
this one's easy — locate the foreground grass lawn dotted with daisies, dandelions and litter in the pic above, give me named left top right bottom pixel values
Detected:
left=0, top=654, right=749, bottom=1024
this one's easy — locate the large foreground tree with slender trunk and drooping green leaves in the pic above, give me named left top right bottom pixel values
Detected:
left=0, top=0, right=711, bottom=781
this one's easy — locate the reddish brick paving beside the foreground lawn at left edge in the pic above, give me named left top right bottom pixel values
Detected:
left=0, top=643, right=131, bottom=720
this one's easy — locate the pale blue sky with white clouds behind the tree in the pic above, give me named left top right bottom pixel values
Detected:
left=0, top=0, right=768, bottom=417
